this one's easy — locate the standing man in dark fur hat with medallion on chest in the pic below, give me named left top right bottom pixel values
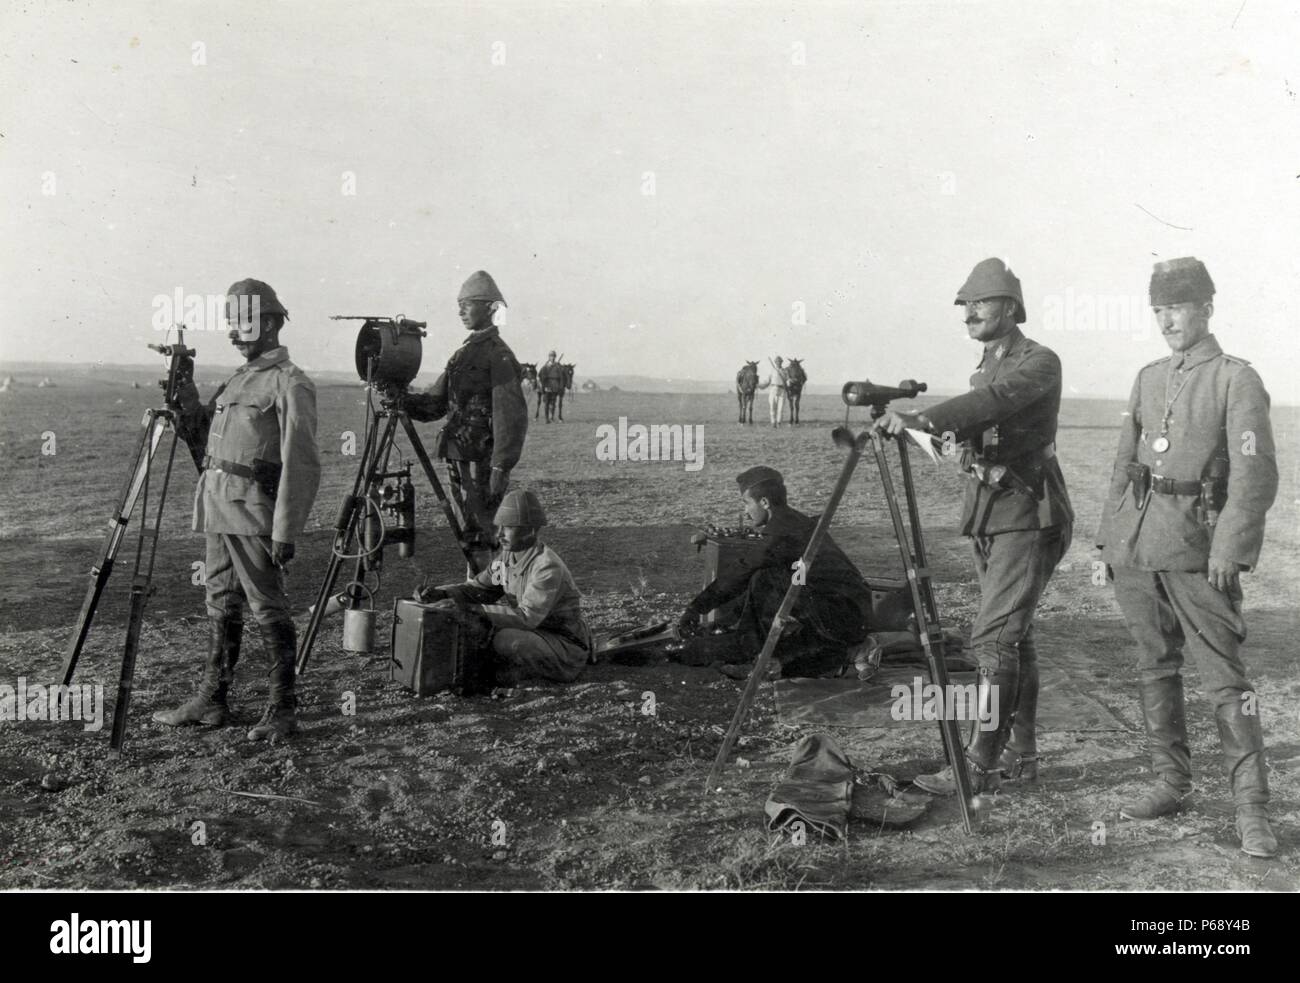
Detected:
left=1097, top=256, right=1278, bottom=857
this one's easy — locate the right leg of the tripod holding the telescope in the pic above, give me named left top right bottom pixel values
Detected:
left=871, top=430, right=974, bottom=833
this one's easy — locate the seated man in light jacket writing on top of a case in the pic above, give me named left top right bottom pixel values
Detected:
left=416, top=490, right=592, bottom=687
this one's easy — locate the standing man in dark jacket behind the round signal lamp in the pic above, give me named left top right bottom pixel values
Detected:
left=407, top=270, right=528, bottom=573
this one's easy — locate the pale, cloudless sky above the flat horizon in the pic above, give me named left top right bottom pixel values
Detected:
left=0, top=0, right=1300, bottom=403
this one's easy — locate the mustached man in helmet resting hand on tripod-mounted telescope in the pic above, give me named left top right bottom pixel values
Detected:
left=876, top=259, right=1074, bottom=794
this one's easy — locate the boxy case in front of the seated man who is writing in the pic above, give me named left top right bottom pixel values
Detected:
left=389, top=598, right=475, bottom=696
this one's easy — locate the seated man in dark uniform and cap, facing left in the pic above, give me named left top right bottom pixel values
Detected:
left=677, top=467, right=871, bottom=676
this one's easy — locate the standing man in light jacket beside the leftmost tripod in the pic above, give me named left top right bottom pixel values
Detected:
left=153, top=280, right=321, bottom=741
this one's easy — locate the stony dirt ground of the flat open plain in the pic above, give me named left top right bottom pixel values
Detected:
left=0, top=376, right=1300, bottom=891
